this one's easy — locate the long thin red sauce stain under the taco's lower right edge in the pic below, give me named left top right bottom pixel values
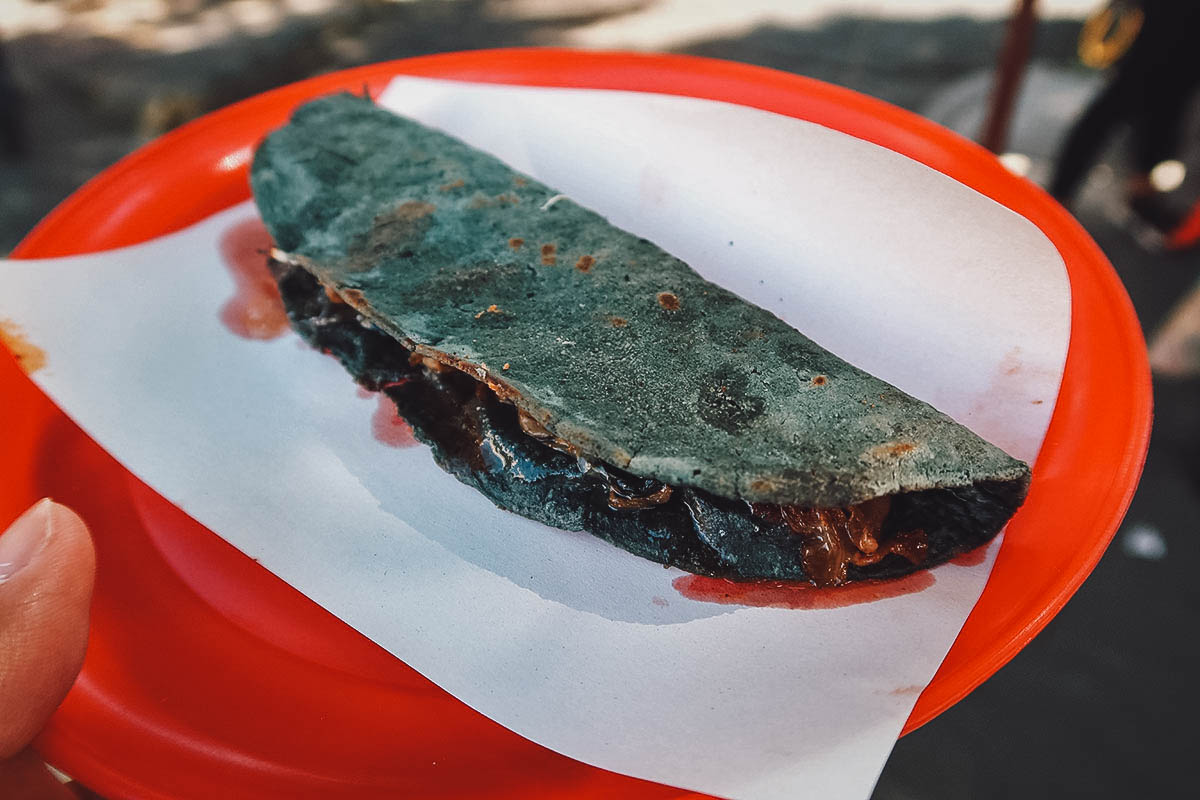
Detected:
left=671, top=570, right=936, bottom=610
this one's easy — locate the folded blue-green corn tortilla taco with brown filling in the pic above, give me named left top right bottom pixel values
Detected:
left=251, top=95, right=1030, bottom=585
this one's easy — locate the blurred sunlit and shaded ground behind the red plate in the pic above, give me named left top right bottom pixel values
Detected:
left=0, top=0, right=1200, bottom=800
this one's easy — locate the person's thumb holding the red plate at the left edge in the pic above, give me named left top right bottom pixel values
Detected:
left=0, top=500, right=96, bottom=760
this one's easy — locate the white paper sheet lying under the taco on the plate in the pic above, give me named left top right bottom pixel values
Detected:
left=0, top=78, right=1070, bottom=799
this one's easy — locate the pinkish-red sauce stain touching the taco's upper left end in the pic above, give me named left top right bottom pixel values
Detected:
left=221, top=219, right=288, bottom=339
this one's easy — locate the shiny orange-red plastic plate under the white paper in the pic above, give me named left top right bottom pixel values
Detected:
left=0, top=50, right=1151, bottom=799
